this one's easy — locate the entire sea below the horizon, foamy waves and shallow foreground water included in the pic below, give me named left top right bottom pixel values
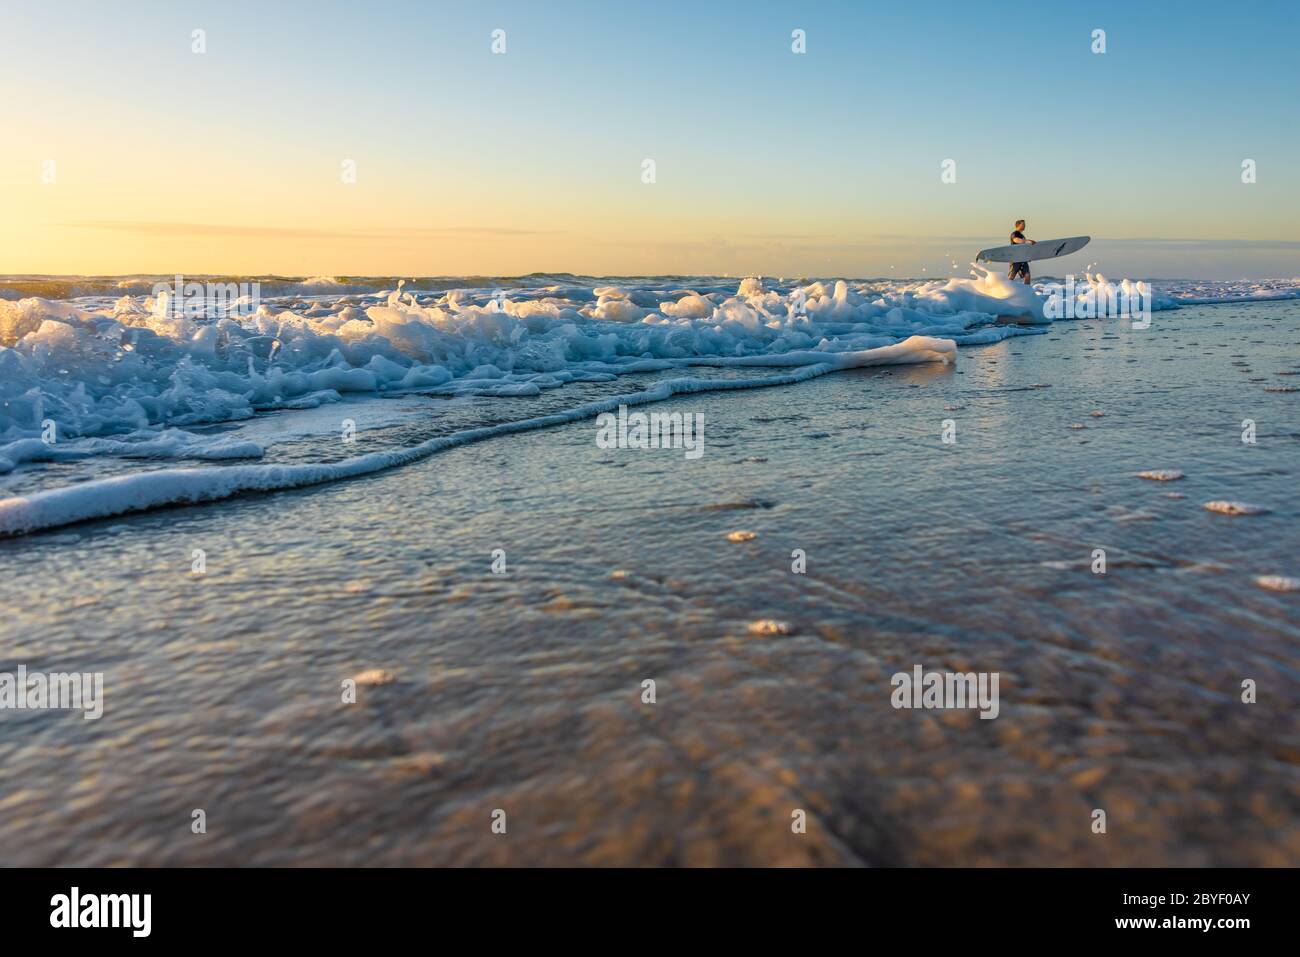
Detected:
left=0, top=272, right=1300, bottom=866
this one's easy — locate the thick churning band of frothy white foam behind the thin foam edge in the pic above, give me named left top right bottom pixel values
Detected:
left=0, top=268, right=1196, bottom=460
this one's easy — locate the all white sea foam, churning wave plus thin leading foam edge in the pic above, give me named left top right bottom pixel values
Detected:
left=0, top=267, right=1300, bottom=531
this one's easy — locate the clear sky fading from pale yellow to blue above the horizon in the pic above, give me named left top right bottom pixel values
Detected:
left=0, top=0, right=1300, bottom=278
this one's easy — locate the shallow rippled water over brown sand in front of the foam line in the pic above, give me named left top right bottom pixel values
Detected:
left=0, top=303, right=1300, bottom=865
